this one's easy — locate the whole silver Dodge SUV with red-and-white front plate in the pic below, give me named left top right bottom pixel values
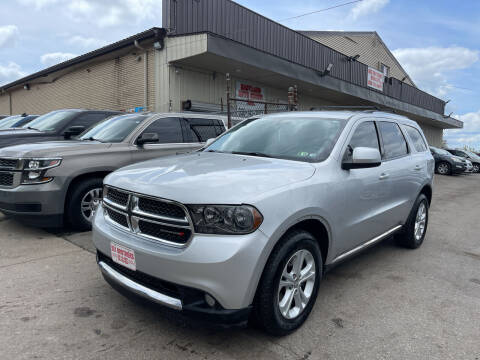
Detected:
left=93, top=111, right=434, bottom=335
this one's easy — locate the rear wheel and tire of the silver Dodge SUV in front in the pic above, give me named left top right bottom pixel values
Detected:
left=395, top=194, right=429, bottom=249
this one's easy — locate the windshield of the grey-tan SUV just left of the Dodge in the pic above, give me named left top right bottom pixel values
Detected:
left=80, top=114, right=147, bottom=143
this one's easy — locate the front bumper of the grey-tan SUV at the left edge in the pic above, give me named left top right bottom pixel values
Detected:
left=0, top=178, right=65, bottom=227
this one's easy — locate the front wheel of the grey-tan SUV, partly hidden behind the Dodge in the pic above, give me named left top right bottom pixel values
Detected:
left=65, top=178, right=103, bottom=231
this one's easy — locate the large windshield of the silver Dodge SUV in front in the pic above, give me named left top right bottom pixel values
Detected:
left=203, top=115, right=346, bottom=162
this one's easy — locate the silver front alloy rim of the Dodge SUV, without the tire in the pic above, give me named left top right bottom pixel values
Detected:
left=278, top=249, right=316, bottom=319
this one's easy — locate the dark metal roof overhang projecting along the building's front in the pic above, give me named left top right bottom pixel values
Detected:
left=171, top=33, right=463, bottom=129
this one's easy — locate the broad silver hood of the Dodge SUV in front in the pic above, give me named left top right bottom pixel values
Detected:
left=104, top=152, right=315, bottom=204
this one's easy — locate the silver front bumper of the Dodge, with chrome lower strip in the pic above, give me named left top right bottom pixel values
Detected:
left=93, top=207, right=268, bottom=322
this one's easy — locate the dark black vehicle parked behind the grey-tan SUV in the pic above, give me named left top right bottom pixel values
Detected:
left=0, top=109, right=120, bottom=148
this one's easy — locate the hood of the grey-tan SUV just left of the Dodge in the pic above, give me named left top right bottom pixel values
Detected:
left=0, top=140, right=111, bottom=158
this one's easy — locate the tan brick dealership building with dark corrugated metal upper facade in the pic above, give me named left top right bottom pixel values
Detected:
left=0, top=0, right=463, bottom=146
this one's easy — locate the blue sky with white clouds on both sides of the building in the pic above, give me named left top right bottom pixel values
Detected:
left=0, top=0, right=480, bottom=149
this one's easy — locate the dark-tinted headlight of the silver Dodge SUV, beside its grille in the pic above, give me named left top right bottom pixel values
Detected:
left=188, top=205, right=263, bottom=235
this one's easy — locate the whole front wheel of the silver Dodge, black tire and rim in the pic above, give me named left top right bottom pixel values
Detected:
left=254, top=230, right=323, bottom=336
